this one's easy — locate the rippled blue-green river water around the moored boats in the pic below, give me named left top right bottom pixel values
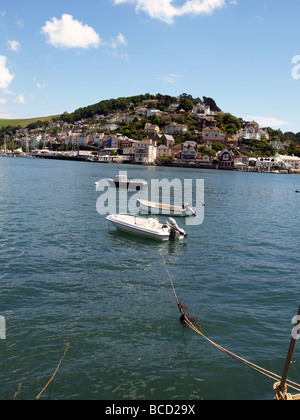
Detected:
left=0, top=158, right=300, bottom=400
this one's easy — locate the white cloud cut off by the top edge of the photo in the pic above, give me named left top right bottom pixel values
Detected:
left=113, top=0, right=225, bottom=24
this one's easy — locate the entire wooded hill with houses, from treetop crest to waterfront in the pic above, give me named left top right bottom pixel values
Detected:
left=0, top=94, right=300, bottom=173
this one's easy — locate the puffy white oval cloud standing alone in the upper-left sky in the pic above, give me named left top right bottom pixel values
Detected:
left=42, top=14, right=101, bottom=49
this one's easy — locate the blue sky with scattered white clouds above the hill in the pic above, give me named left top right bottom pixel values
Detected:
left=0, top=0, right=300, bottom=132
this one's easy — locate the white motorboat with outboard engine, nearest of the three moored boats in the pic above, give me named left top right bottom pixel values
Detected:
left=106, top=214, right=187, bottom=241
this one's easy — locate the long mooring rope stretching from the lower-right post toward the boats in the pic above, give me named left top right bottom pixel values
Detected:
left=162, top=256, right=300, bottom=399
